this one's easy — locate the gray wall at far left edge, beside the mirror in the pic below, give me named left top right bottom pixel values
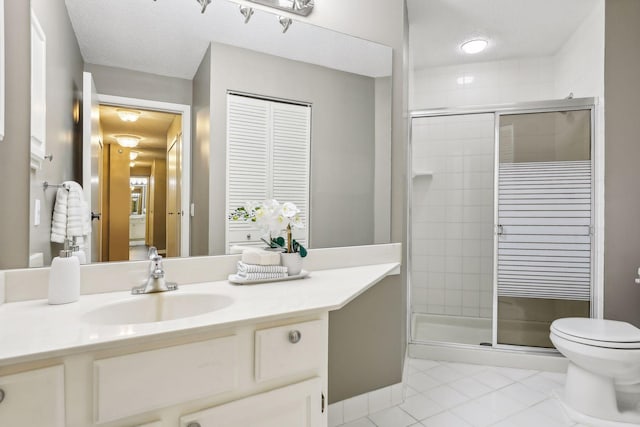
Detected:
left=0, top=1, right=31, bottom=269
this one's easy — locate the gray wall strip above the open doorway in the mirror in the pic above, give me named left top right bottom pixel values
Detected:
left=84, top=63, right=191, bottom=105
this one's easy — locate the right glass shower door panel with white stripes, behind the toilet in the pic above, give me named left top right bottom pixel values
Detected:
left=496, top=109, right=593, bottom=347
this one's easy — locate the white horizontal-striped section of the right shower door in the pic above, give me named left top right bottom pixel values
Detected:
left=498, top=161, right=592, bottom=301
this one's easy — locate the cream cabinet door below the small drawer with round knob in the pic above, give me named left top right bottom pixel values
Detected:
left=180, top=378, right=326, bottom=427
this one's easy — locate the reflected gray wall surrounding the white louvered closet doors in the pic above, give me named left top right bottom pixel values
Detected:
left=206, top=43, right=375, bottom=254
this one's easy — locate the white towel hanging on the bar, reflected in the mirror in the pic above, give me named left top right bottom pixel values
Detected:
left=51, top=181, right=91, bottom=246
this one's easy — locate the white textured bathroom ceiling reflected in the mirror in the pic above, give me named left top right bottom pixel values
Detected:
left=65, top=0, right=391, bottom=80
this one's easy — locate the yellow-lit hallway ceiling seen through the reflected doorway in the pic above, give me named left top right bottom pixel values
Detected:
left=100, top=105, right=176, bottom=167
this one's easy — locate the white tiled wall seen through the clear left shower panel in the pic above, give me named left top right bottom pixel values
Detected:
left=411, top=114, right=494, bottom=317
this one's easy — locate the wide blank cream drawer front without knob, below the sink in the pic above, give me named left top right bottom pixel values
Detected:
left=93, top=336, right=237, bottom=423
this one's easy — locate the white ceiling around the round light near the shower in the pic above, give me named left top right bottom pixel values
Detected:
left=407, top=0, right=603, bottom=69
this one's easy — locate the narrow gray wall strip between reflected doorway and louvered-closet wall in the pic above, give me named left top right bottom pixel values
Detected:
left=191, top=47, right=211, bottom=255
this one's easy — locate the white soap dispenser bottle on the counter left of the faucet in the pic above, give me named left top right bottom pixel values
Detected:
left=49, top=239, right=80, bottom=304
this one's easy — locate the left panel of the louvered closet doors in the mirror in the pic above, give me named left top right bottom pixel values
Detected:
left=226, top=95, right=271, bottom=249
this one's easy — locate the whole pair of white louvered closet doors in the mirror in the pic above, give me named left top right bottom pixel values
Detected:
left=226, top=94, right=311, bottom=249
